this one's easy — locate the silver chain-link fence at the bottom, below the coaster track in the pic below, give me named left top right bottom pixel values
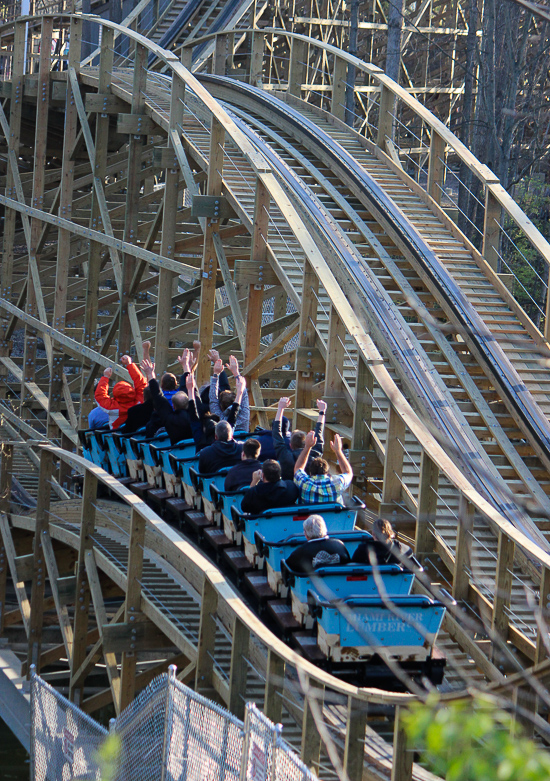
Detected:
left=31, top=668, right=322, bottom=781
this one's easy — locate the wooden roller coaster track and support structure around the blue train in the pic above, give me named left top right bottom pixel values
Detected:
left=0, top=15, right=550, bottom=781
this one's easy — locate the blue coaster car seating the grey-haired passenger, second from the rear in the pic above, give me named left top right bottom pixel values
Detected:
left=281, top=560, right=414, bottom=627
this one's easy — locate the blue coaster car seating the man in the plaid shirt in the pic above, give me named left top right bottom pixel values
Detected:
left=231, top=497, right=365, bottom=564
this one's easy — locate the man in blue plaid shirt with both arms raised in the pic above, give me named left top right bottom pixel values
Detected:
left=294, top=431, right=353, bottom=504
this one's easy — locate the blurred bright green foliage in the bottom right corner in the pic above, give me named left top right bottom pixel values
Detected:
left=403, top=695, right=550, bottom=781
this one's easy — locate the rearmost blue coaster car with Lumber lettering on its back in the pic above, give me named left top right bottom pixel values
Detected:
left=307, top=590, right=445, bottom=662
